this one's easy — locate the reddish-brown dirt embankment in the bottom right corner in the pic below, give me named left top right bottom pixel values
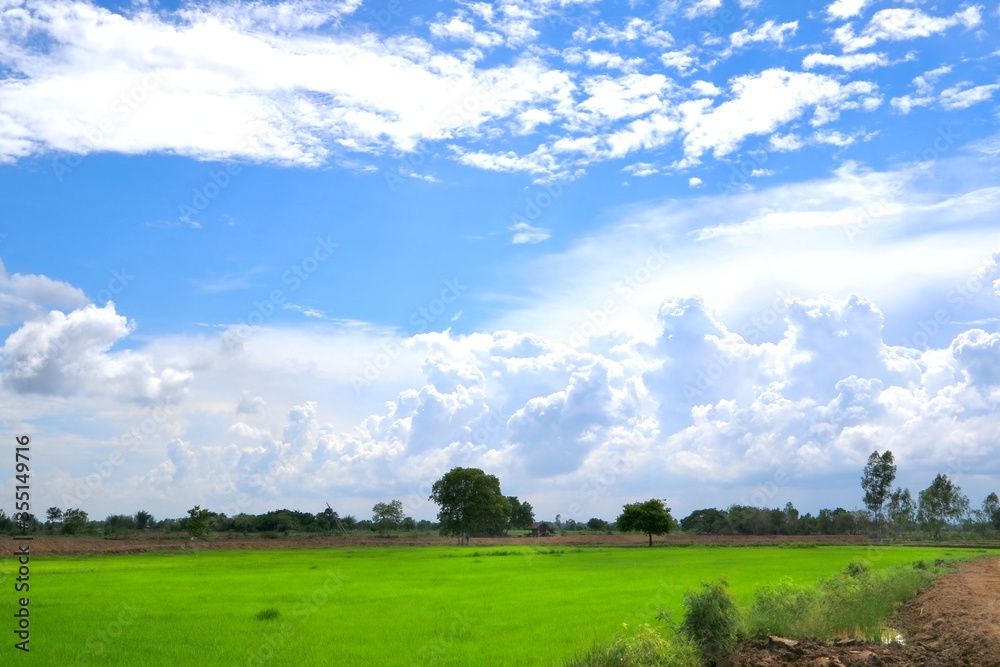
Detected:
left=727, top=557, right=1000, bottom=667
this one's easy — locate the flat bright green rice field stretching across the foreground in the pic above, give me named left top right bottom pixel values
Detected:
left=0, top=547, right=974, bottom=667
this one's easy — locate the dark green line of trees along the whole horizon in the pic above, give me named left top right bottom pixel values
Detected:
left=9, top=450, right=1000, bottom=545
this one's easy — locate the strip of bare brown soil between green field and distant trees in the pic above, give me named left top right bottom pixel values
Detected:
left=21, top=533, right=871, bottom=556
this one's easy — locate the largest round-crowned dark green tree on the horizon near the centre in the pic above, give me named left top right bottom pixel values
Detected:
left=429, top=468, right=510, bottom=543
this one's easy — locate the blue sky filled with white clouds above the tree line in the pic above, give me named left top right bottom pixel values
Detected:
left=0, top=0, right=1000, bottom=520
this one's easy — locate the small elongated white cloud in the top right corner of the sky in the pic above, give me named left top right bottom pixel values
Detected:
left=834, top=6, right=982, bottom=52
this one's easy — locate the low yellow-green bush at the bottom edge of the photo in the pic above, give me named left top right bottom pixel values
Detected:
left=566, top=625, right=698, bottom=667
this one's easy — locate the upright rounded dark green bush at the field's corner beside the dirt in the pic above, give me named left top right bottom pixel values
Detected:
left=680, top=579, right=739, bottom=666
